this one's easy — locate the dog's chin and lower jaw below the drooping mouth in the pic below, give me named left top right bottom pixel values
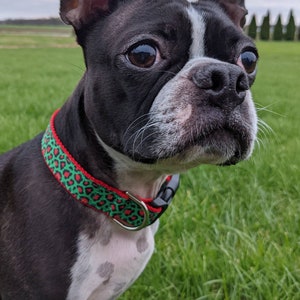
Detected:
left=124, top=129, right=254, bottom=173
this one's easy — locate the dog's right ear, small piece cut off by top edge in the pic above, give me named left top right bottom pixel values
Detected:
left=217, top=0, right=248, bottom=29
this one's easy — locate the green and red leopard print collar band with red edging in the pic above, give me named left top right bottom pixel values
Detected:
left=42, top=112, right=160, bottom=229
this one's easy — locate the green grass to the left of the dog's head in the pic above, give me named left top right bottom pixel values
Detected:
left=0, top=36, right=84, bottom=153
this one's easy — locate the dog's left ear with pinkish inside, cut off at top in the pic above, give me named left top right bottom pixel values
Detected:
left=60, top=0, right=118, bottom=30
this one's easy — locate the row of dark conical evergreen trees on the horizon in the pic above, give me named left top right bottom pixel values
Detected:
left=248, top=10, right=300, bottom=41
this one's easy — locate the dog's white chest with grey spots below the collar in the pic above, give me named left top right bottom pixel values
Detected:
left=67, top=224, right=155, bottom=300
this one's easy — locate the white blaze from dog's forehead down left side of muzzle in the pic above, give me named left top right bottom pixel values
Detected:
left=146, top=6, right=206, bottom=162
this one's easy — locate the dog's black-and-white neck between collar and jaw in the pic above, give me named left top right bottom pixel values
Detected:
left=55, top=79, right=167, bottom=198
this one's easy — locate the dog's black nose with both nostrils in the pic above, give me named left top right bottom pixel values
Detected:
left=192, top=63, right=249, bottom=109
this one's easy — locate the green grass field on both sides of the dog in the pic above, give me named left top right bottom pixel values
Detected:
left=0, top=29, right=300, bottom=300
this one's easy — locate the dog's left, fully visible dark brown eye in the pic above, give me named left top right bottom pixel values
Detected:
left=127, top=44, right=157, bottom=68
